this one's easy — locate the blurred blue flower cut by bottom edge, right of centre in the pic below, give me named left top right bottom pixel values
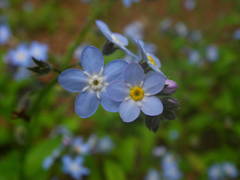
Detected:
left=162, top=153, right=182, bottom=180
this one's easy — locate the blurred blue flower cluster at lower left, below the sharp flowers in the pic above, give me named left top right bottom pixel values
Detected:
left=43, top=127, right=114, bottom=180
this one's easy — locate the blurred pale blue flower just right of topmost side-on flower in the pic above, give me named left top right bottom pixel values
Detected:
left=124, top=21, right=143, bottom=39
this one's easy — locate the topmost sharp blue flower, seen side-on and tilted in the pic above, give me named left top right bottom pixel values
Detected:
left=96, top=20, right=135, bottom=56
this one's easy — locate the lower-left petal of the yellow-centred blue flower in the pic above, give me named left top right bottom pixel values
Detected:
left=119, top=100, right=140, bottom=122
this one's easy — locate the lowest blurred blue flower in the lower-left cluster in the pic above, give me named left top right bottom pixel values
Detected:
left=62, top=155, right=89, bottom=179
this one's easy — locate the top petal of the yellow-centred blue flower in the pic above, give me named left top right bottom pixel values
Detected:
left=124, top=63, right=144, bottom=85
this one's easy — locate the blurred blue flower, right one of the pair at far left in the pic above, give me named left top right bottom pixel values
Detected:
left=29, top=42, right=48, bottom=61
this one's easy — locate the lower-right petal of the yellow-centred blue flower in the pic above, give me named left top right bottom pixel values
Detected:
left=141, top=96, right=163, bottom=116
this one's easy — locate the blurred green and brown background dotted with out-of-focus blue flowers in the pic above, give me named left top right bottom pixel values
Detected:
left=0, top=0, right=240, bottom=180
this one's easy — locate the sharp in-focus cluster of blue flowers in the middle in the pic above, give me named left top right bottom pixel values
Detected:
left=58, top=20, right=177, bottom=130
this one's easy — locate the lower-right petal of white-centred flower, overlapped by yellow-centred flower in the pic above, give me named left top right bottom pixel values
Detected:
left=101, top=92, right=120, bottom=112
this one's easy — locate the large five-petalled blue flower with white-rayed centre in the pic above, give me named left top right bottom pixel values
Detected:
left=58, top=46, right=127, bottom=118
